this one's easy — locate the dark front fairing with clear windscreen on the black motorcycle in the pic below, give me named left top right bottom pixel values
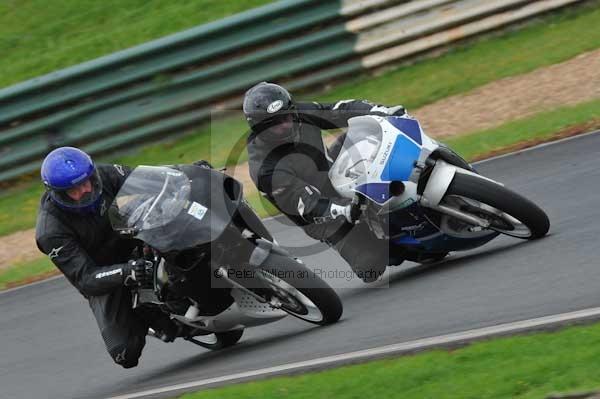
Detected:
left=110, top=165, right=242, bottom=252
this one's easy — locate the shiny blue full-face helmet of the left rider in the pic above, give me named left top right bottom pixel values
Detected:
left=41, top=147, right=102, bottom=213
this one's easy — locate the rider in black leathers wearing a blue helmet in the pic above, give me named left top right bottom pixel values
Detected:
left=36, top=147, right=177, bottom=368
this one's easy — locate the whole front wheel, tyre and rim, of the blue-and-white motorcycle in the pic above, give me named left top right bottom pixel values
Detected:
left=442, top=173, right=550, bottom=239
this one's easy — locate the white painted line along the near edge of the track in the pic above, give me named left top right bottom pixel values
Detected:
left=108, top=308, right=600, bottom=399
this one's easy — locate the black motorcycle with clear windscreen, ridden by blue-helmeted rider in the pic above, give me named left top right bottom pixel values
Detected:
left=109, top=165, right=342, bottom=349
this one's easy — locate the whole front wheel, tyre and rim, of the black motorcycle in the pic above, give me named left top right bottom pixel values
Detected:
left=258, top=252, right=343, bottom=325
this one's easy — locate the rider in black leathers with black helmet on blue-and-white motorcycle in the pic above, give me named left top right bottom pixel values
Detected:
left=243, top=82, right=405, bottom=282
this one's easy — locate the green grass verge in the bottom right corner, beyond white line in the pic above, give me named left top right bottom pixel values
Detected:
left=175, top=324, right=600, bottom=399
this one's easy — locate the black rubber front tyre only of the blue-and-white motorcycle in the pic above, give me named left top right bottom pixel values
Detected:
left=442, top=173, right=550, bottom=240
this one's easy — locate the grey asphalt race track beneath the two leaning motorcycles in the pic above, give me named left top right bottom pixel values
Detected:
left=0, top=132, right=600, bottom=399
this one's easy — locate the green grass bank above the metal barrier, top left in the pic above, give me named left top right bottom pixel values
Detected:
left=0, top=0, right=271, bottom=87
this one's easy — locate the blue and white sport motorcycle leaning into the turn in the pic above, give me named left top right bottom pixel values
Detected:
left=329, top=116, right=550, bottom=262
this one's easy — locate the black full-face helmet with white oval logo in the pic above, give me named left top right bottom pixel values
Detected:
left=244, top=82, right=299, bottom=142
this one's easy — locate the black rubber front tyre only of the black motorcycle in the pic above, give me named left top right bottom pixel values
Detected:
left=261, top=252, right=343, bottom=325
